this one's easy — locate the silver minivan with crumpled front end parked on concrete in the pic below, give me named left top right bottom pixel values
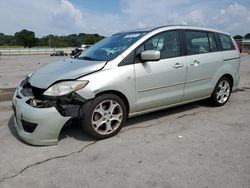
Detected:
left=13, top=26, right=240, bottom=145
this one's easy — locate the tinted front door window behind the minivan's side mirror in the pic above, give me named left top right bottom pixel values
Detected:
left=136, top=31, right=181, bottom=59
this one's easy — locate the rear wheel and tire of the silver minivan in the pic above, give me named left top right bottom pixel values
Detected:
left=210, top=77, right=232, bottom=106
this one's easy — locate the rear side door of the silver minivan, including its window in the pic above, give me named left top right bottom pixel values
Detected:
left=183, top=30, right=223, bottom=101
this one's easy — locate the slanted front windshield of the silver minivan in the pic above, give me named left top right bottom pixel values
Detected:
left=77, top=31, right=146, bottom=61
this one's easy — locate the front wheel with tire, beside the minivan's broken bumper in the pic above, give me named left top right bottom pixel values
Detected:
left=81, top=94, right=127, bottom=139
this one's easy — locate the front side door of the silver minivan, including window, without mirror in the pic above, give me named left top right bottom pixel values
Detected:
left=134, top=30, right=186, bottom=111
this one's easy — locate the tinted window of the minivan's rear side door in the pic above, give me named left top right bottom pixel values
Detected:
left=185, top=31, right=211, bottom=55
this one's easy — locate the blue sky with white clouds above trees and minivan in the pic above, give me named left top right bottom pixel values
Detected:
left=0, top=0, right=250, bottom=37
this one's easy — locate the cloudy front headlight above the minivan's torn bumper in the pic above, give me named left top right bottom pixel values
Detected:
left=43, top=80, right=88, bottom=96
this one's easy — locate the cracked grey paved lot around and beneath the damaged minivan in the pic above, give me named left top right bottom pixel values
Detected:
left=0, top=56, right=250, bottom=188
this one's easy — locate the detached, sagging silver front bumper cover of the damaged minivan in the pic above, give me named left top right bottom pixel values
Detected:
left=12, top=87, right=71, bottom=145
